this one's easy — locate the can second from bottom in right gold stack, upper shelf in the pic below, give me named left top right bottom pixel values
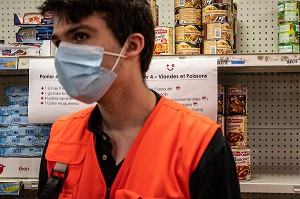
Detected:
left=203, top=22, right=233, bottom=40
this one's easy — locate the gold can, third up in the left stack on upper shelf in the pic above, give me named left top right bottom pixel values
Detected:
left=175, top=8, right=201, bottom=25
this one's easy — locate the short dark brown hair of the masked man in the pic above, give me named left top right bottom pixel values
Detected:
left=40, top=0, right=154, bottom=78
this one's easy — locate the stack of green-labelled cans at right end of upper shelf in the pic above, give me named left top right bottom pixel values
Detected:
left=278, top=1, right=300, bottom=53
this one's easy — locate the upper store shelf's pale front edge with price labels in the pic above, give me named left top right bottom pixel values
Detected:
left=1, top=53, right=300, bottom=73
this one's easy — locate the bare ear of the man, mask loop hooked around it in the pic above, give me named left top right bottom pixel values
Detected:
left=125, top=33, right=145, bottom=57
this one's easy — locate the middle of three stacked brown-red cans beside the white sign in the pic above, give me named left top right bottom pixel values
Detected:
left=225, top=115, right=247, bottom=147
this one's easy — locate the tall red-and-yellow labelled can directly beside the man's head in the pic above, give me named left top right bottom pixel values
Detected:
left=153, top=27, right=174, bottom=55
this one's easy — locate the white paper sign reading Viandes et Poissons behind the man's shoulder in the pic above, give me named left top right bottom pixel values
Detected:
left=146, top=57, right=217, bottom=120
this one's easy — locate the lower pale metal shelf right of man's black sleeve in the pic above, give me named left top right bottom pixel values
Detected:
left=240, top=174, right=300, bottom=194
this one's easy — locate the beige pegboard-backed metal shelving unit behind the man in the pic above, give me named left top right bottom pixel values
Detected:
left=0, top=0, right=300, bottom=199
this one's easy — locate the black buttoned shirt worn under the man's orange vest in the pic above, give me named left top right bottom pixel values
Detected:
left=38, top=94, right=241, bottom=199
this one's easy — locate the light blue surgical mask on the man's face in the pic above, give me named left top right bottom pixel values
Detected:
left=55, top=41, right=127, bottom=104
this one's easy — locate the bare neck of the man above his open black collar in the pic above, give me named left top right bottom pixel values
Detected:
left=99, top=87, right=156, bottom=164
